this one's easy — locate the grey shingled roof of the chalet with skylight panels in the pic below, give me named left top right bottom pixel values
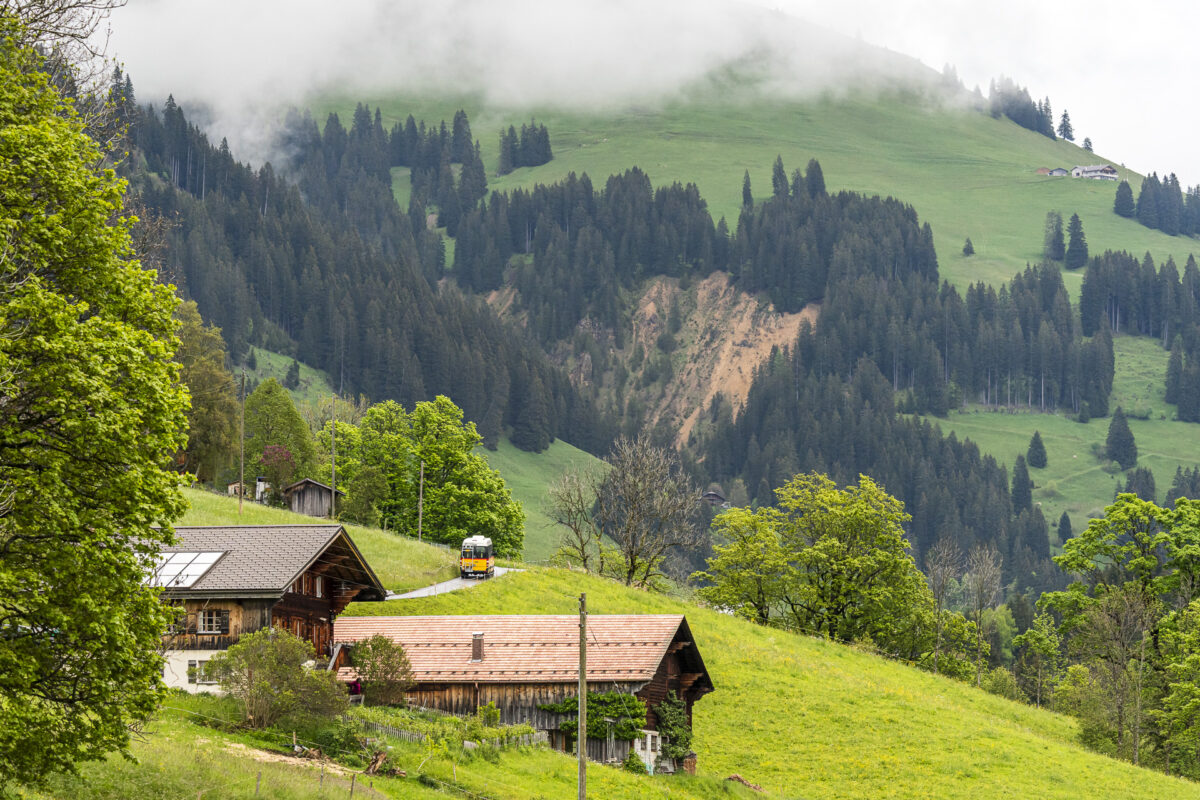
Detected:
left=162, top=525, right=388, bottom=600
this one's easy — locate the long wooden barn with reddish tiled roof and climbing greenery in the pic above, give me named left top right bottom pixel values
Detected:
left=334, top=614, right=713, bottom=769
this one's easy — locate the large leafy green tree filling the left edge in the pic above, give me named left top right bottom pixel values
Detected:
left=0, top=18, right=187, bottom=790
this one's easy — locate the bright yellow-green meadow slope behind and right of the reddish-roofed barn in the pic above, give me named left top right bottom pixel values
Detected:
left=347, top=567, right=1198, bottom=800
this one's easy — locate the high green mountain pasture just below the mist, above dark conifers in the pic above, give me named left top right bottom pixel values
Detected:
left=310, top=90, right=1200, bottom=297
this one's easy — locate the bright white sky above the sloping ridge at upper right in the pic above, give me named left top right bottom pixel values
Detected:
left=752, top=0, right=1200, bottom=186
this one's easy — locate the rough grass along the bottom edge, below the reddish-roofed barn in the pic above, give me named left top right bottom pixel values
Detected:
left=32, top=694, right=761, bottom=800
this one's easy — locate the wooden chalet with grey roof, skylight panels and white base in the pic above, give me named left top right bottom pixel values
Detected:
left=149, top=524, right=388, bottom=691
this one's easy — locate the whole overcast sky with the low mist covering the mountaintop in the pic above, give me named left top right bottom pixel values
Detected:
left=109, top=0, right=1200, bottom=186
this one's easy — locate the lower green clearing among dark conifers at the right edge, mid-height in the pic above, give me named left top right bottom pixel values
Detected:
left=916, top=336, right=1200, bottom=545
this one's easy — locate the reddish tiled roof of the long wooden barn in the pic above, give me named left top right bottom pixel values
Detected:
left=334, top=614, right=684, bottom=684
